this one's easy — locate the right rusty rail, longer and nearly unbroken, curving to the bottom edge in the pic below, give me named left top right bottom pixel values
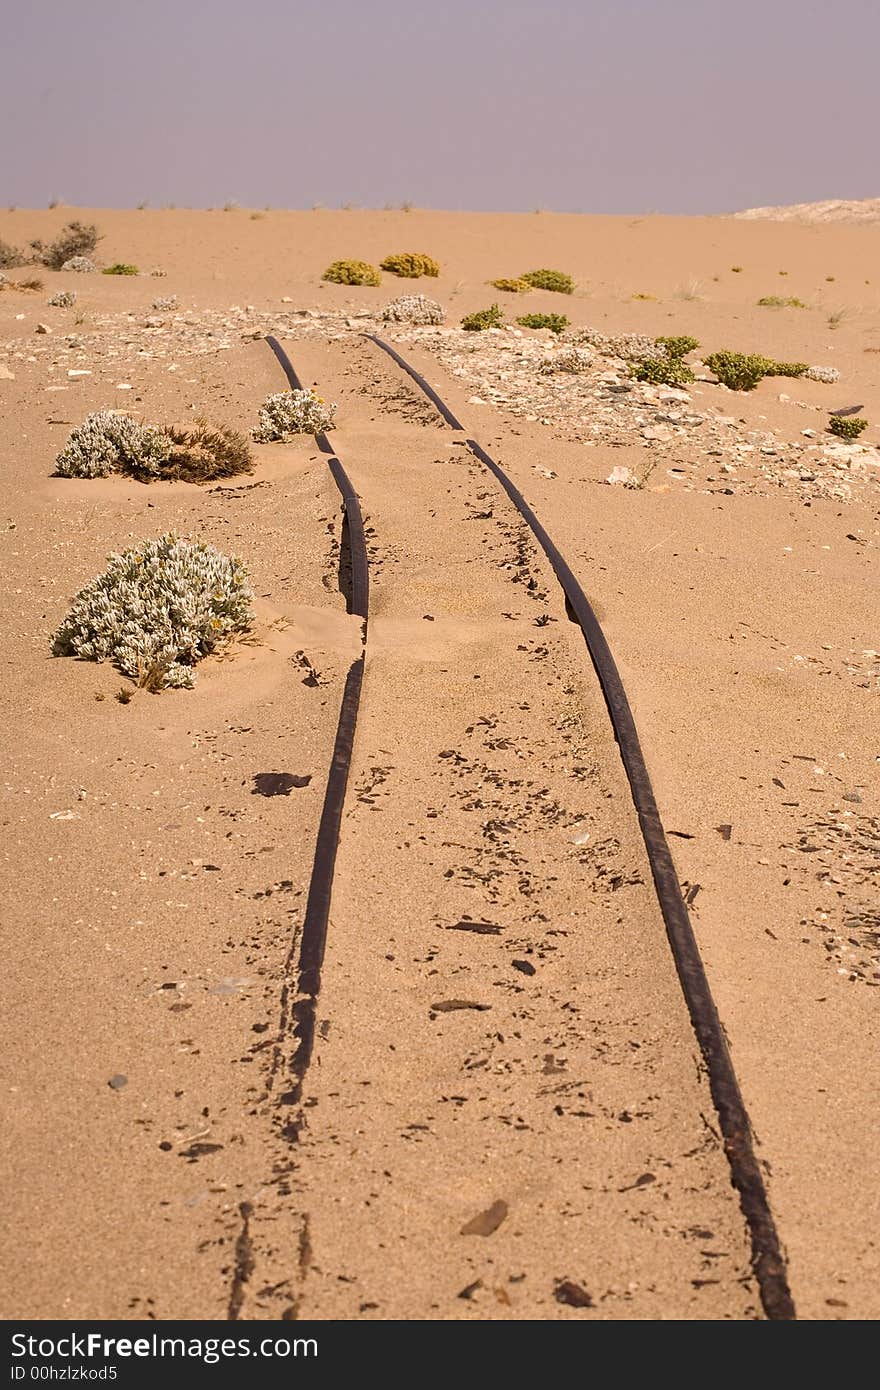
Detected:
left=364, top=334, right=797, bottom=1321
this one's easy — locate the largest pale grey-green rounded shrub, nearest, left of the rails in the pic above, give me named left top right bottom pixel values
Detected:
left=51, top=535, right=253, bottom=689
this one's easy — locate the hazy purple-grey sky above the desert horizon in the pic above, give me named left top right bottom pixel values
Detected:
left=6, top=0, right=880, bottom=213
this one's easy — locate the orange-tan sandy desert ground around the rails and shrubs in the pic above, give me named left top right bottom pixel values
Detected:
left=0, top=209, right=880, bottom=1319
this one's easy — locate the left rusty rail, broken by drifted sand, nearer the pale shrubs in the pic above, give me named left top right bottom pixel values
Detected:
left=267, top=338, right=370, bottom=1117
